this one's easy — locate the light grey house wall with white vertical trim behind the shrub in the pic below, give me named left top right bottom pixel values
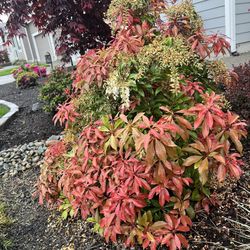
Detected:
left=193, top=0, right=250, bottom=53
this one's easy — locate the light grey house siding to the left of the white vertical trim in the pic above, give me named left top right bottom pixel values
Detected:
left=193, top=0, right=225, bottom=34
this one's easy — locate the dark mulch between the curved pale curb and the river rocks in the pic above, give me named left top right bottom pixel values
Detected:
left=0, top=82, right=61, bottom=150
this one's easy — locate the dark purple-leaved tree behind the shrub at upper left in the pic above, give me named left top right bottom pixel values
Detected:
left=0, top=0, right=111, bottom=61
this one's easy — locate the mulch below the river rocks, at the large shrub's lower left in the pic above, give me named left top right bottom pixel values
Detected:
left=0, top=167, right=110, bottom=250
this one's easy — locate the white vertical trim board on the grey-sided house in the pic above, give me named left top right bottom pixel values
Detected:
left=225, top=0, right=237, bottom=53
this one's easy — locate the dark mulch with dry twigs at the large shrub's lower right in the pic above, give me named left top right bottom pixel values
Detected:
left=189, top=150, right=250, bottom=250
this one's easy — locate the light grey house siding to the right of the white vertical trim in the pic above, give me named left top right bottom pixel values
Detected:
left=235, top=0, right=250, bottom=51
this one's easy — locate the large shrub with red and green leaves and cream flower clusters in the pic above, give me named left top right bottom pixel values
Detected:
left=38, top=0, right=246, bottom=249
